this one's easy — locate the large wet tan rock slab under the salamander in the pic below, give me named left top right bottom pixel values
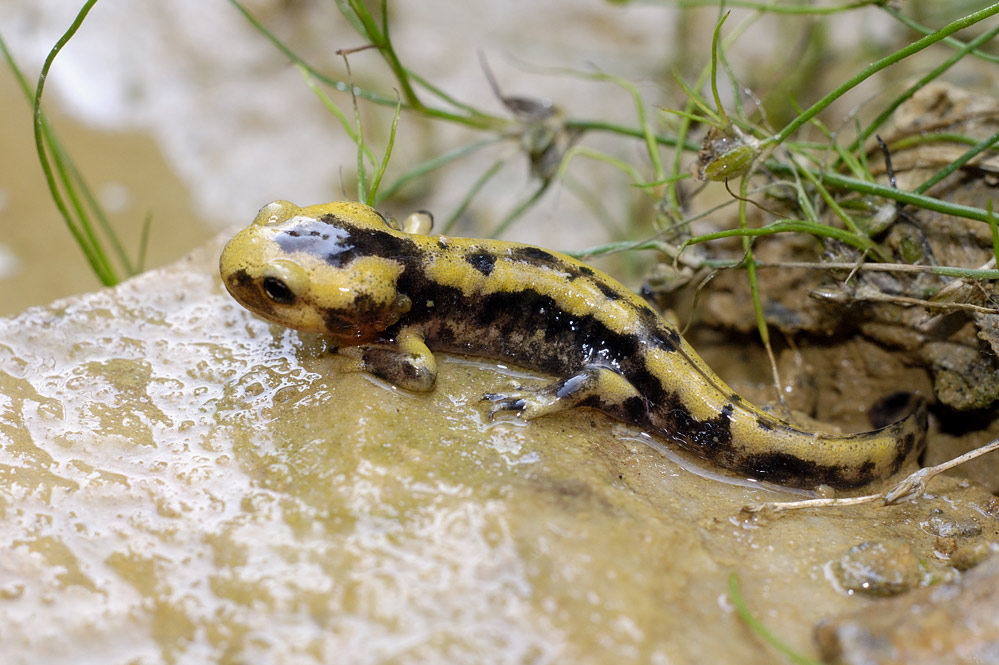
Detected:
left=0, top=235, right=999, bottom=665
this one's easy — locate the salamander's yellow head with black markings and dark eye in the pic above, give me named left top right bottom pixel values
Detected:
left=219, top=201, right=416, bottom=345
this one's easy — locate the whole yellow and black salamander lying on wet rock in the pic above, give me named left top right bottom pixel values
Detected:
left=220, top=201, right=926, bottom=488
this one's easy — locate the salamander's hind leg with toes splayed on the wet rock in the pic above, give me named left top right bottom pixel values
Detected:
left=482, top=365, right=646, bottom=420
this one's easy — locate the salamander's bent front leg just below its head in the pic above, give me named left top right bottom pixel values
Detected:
left=337, top=332, right=437, bottom=392
